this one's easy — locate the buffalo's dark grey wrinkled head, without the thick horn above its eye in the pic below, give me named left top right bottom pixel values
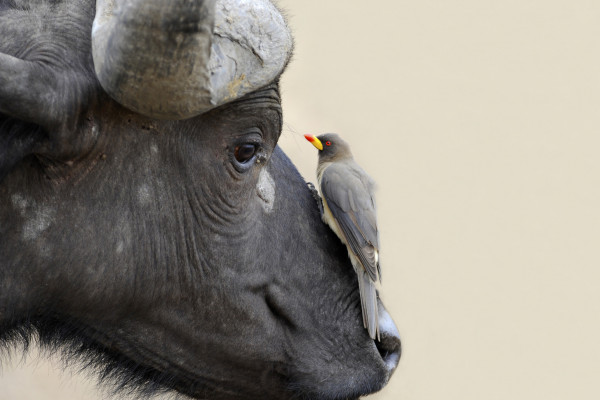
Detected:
left=0, top=0, right=400, bottom=399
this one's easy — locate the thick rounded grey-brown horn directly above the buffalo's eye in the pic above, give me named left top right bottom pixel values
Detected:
left=92, top=0, right=292, bottom=119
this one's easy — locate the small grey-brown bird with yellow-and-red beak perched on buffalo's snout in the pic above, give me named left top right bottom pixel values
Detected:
left=304, top=133, right=381, bottom=340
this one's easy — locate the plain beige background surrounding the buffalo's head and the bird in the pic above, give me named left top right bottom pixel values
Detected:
left=0, top=0, right=600, bottom=400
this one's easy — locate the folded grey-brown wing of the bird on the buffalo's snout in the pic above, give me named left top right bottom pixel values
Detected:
left=321, top=162, right=380, bottom=282
